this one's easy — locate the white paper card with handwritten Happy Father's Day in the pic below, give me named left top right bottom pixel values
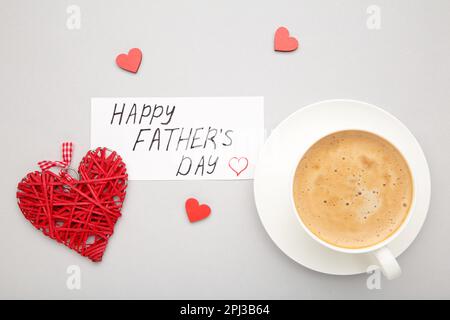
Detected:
left=91, top=97, right=264, bottom=180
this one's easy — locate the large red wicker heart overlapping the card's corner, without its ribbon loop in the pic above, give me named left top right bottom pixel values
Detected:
left=17, top=148, right=128, bottom=262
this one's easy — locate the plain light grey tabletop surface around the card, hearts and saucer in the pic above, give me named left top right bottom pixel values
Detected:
left=0, top=0, right=450, bottom=299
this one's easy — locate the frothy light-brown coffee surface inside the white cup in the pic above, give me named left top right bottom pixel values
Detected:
left=293, top=130, right=413, bottom=249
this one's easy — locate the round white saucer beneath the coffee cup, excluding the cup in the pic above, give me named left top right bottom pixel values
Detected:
left=254, top=100, right=431, bottom=275
